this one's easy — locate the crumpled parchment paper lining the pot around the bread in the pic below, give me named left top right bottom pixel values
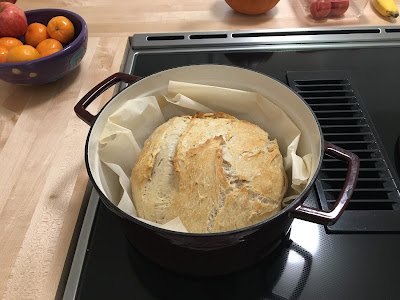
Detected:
left=99, top=81, right=312, bottom=232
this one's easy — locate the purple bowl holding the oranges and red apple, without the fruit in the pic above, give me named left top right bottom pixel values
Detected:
left=0, top=9, right=88, bottom=84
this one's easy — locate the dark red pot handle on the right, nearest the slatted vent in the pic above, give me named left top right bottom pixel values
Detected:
left=291, top=142, right=360, bottom=225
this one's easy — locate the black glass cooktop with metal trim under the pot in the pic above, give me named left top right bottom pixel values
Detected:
left=59, top=27, right=400, bottom=299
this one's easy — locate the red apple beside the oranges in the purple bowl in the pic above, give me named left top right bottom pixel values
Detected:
left=0, top=2, right=28, bottom=37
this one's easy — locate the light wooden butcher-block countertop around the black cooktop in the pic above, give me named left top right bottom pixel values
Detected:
left=0, top=0, right=400, bottom=299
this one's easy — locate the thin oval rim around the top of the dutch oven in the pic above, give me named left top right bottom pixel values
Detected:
left=85, top=64, right=324, bottom=238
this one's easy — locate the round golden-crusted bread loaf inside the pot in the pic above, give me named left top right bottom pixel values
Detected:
left=131, top=113, right=287, bottom=233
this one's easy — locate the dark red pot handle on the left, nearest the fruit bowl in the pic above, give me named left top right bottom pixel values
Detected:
left=74, top=72, right=140, bottom=125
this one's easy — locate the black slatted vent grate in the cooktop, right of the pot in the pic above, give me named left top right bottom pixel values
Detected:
left=287, top=71, right=400, bottom=233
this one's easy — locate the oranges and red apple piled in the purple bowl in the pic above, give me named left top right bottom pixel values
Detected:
left=0, top=2, right=75, bottom=63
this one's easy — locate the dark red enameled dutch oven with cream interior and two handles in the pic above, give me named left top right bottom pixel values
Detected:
left=75, top=65, right=359, bottom=276
